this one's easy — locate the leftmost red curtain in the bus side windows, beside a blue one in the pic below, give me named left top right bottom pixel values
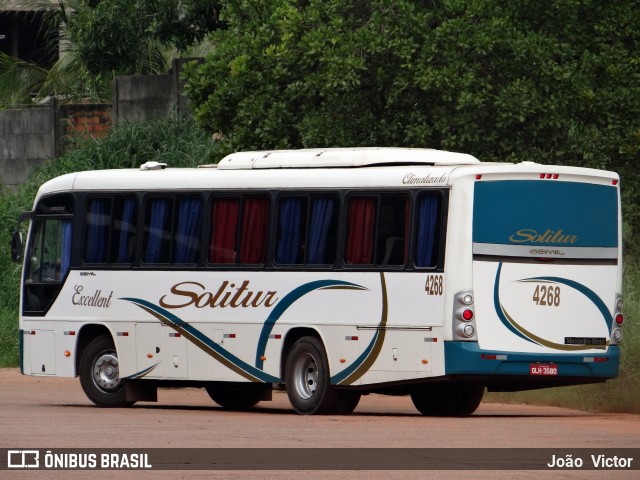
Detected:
left=209, top=198, right=240, bottom=263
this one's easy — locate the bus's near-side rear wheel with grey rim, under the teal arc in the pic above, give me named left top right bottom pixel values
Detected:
left=285, top=337, right=342, bottom=415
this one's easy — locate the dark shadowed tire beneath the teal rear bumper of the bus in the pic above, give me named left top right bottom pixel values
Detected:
left=411, top=383, right=484, bottom=417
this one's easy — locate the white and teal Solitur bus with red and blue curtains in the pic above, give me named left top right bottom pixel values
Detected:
left=13, top=148, right=623, bottom=415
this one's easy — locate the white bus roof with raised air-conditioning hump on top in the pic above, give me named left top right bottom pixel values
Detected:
left=36, top=148, right=619, bottom=201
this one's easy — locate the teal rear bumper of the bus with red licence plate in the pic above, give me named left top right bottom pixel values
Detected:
left=444, top=342, right=620, bottom=383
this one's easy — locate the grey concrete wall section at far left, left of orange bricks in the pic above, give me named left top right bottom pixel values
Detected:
left=0, top=105, right=57, bottom=190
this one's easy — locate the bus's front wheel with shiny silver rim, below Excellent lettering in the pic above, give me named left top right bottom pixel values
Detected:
left=79, top=335, right=135, bottom=407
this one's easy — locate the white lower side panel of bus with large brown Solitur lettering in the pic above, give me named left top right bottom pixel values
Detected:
left=42, top=270, right=445, bottom=385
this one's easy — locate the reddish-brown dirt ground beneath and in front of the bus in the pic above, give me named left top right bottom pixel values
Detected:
left=0, top=369, right=640, bottom=480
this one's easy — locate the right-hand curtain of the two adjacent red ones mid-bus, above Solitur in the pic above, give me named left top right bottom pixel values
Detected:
left=240, top=197, right=269, bottom=263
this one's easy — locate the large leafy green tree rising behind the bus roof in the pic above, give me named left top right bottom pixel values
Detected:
left=186, top=0, right=640, bottom=240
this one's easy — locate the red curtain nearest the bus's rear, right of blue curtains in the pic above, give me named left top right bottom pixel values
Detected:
left=344, top=198, right=376, bottom=265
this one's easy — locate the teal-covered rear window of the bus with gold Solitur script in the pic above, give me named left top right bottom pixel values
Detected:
left=473, top=180, right=618, bottom=258
